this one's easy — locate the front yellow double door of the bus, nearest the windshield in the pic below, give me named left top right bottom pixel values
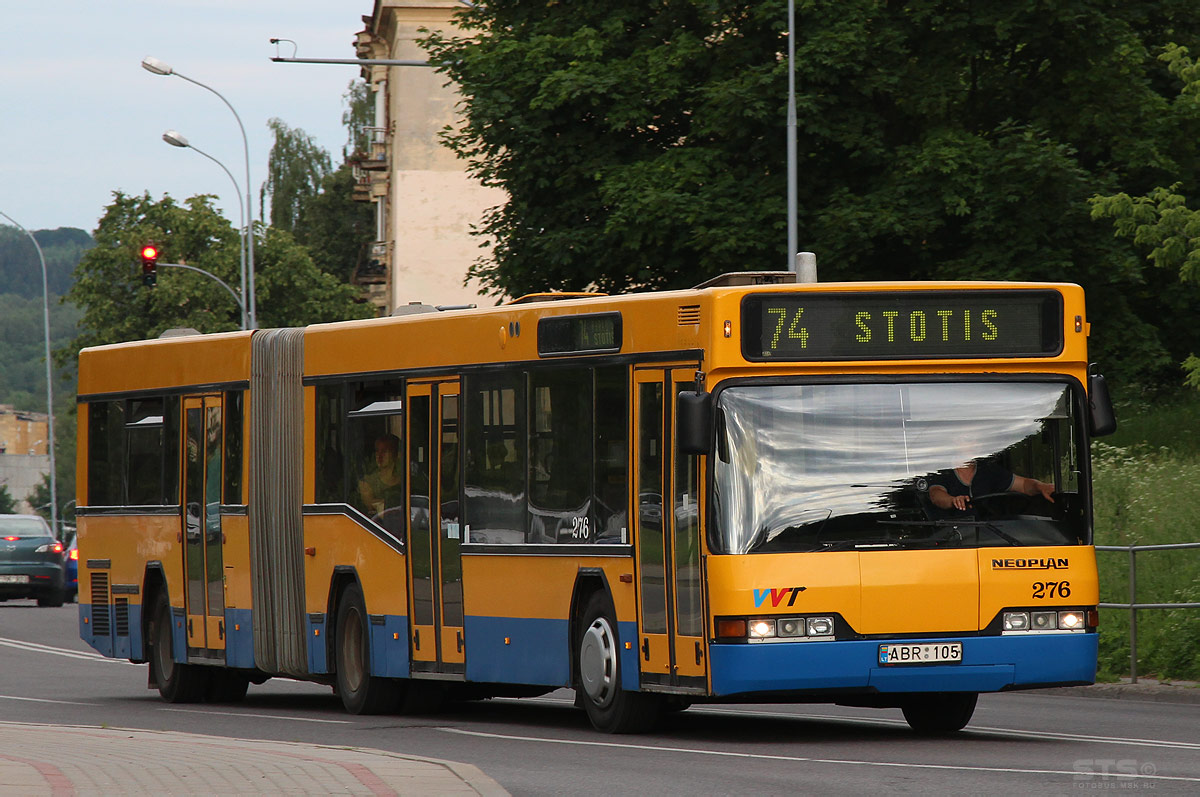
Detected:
left=634, top=366, right=707, bottom=688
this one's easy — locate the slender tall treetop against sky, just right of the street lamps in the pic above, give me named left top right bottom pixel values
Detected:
left=259, top=118, right=332, bottom=233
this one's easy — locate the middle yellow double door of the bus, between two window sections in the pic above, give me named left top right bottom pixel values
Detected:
left=408, top=379, right=466, bottom=673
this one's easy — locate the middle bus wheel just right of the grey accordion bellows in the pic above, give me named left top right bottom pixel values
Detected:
left=334, top=582, right=401, bottom=714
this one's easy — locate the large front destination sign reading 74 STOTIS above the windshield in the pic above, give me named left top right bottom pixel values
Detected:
left=742, top=289, right=1063, bottom=360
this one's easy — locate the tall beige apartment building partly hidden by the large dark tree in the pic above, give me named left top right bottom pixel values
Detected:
left=355, top=0, right=505, bottom=314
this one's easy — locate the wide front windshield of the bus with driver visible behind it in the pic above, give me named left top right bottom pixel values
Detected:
left=710, top=382, right=1087, bottom=553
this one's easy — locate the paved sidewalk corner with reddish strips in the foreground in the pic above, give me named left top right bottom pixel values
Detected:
left=0, top=723, right=508, bottom=797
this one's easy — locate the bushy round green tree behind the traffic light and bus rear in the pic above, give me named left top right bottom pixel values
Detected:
left=66, top=192, right=367, bottom=356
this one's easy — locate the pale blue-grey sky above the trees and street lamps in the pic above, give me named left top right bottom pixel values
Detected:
left=0, top=0, right=373, bottom=233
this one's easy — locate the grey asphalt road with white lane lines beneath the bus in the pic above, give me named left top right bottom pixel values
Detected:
left=0, top=601, right=1200, bottom=795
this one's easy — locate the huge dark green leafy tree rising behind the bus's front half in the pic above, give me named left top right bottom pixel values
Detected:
left=424, top=0, right=1200, bottom=379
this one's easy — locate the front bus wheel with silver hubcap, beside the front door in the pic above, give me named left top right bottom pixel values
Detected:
left=575, top=592, right=661, bottom=733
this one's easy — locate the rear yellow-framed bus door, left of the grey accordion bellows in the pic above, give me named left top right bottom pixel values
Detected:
left=180, top=396, right=226, bottom=659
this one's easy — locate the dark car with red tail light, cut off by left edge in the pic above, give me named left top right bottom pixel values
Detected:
left=0, top=515, right=64, bottom=606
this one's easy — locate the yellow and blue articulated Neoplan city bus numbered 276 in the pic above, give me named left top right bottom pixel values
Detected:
left=78, top=274, right=1115, bottom=732
